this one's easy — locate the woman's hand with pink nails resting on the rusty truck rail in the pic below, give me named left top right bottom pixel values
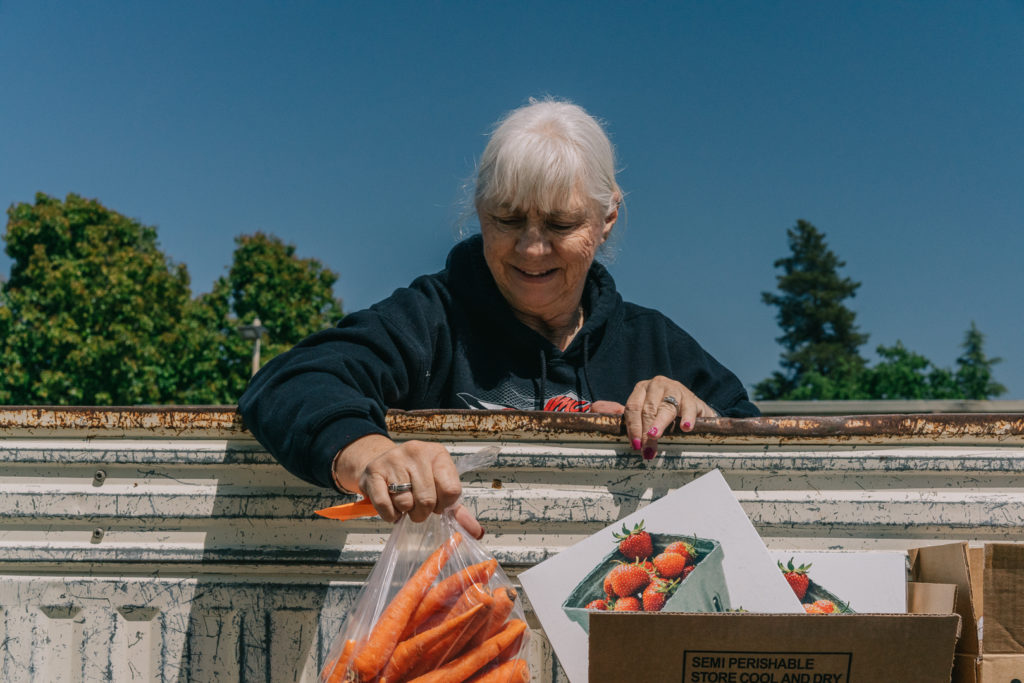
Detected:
left=625, top=375, right=718, bottom=460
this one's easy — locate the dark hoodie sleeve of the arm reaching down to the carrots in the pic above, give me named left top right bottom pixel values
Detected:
left=239, top=280, right=451, bottom=488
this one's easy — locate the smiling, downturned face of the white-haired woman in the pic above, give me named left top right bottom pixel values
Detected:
left=477, top=194, right=618, bottom=323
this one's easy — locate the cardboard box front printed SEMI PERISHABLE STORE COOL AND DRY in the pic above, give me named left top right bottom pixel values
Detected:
left=589, top=612, right=959, bottom=683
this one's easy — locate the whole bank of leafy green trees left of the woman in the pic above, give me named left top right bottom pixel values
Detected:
left=0, top=195, right=342, bottom=405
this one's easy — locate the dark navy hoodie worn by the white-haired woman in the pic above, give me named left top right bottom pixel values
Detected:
left=239, top=236, right=758, bottom=487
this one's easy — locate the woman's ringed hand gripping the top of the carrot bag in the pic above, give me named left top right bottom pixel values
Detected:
left=334, top=434, right=483, bottom=539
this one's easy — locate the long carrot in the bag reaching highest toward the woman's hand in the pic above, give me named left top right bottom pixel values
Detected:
left=352, top=531, right=462, bottom=681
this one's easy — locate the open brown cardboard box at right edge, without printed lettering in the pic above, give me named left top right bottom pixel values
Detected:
left=911, top=543, right=1024, bottom=683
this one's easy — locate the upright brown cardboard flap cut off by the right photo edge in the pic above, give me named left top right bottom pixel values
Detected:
left=982, top=543, right=1024, bottom=654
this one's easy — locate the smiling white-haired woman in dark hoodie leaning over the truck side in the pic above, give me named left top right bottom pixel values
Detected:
left=240, top=100, right=758, bottom=536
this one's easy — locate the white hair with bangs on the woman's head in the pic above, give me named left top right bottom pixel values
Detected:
left=473, top=98, right=622, bottom=214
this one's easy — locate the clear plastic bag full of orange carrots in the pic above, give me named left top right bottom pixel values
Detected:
left=319, top=448, right=530, bottom=683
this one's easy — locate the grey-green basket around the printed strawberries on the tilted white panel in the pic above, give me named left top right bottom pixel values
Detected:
left=562, top=533, right=730, bottom=634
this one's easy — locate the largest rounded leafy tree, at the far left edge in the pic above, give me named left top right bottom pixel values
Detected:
left=0, top=194, right=189, bottom=404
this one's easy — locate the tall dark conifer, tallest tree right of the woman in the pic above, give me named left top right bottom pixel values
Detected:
left=754, top=220, right=867, bottom=399
